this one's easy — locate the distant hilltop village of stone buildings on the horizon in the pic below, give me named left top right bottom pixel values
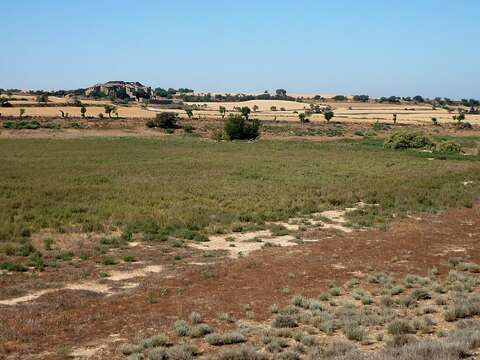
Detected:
left=85, top=81, right=153, bottom=100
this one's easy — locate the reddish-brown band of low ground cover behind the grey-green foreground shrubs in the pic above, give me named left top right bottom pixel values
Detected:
left=0, top=207, right=480, bottom=359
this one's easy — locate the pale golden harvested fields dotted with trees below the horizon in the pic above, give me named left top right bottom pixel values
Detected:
left=0, top=94, right=480, bottom=124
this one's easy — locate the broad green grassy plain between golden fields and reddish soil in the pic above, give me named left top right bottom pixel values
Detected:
left=0, top=136, right=480, bottom=246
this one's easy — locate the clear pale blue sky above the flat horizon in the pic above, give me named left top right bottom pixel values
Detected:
left=0, top=0, right=480, bottom=98
